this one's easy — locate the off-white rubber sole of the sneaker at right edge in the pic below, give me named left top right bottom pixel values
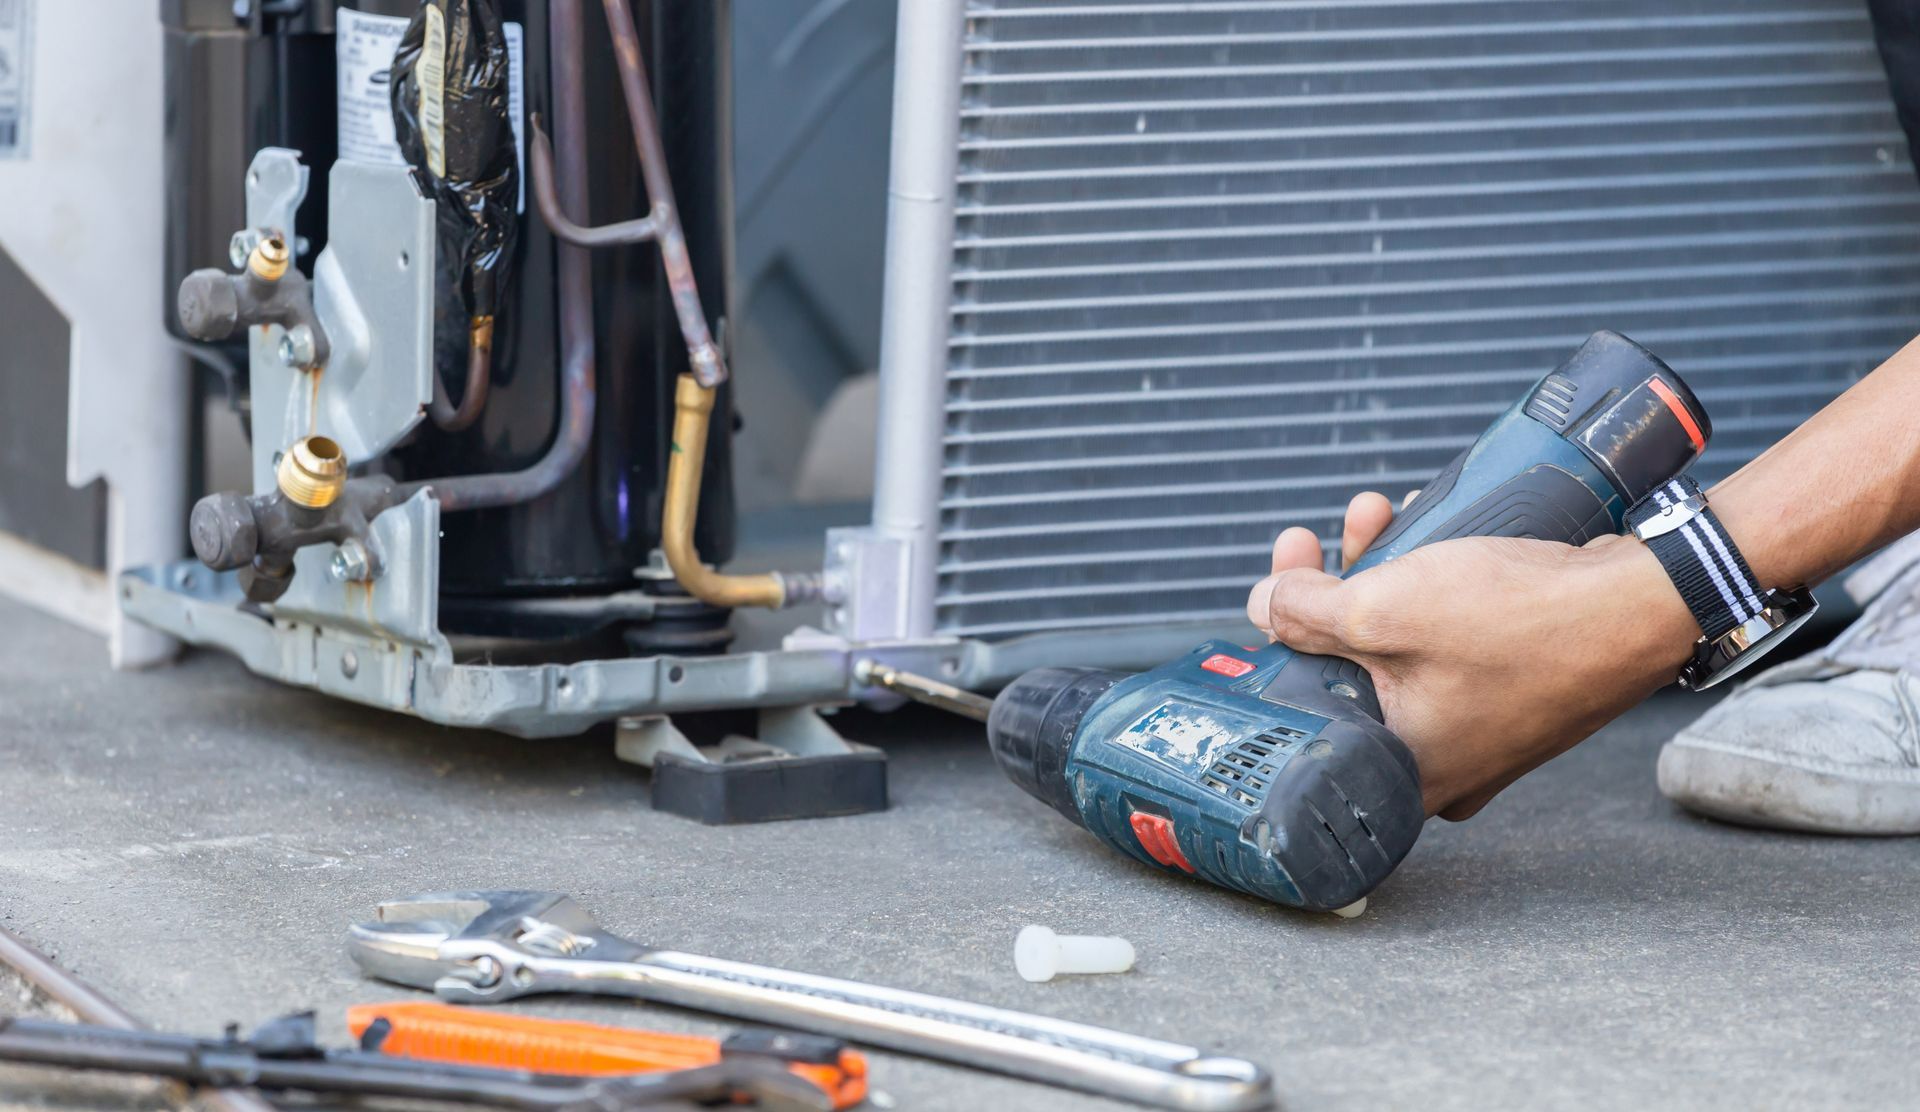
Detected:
left=1657, top=734, right=1920, bottom=835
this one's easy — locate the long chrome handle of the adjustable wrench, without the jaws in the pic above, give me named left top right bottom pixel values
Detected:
left=434, top=935, right=1273, bottom=1112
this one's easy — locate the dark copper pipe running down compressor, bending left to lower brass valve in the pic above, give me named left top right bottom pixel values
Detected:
left=394, top=0, right=595, bottom=511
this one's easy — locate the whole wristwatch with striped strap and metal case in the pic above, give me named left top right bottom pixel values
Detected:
left=1626, top=476, right=1818, bottom=691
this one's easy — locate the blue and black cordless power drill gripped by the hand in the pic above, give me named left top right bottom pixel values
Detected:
left=987, top=332, right=1711, bottom=910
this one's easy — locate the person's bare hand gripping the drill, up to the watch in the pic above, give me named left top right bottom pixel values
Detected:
left=1246, top=494, right=1699, bottom=820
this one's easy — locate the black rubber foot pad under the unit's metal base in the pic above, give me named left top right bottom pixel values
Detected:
left=653, top=745, right=887, bottom=826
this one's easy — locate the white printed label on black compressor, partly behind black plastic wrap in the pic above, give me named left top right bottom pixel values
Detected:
left=332, top=0, right=526, bottom=211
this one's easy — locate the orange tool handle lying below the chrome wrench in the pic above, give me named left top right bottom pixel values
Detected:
left=348, top=1001, right=866, bottom=1108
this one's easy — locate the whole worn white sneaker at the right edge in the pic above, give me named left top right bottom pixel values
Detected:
left=1659, top=534, right=1920, bottom=834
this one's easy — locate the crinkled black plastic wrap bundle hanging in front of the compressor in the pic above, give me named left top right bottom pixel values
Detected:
left=392, top=0, right=520, bottom=365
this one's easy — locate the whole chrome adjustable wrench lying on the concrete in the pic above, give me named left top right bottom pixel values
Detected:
left=348, top=891, right=1273, bottom=1112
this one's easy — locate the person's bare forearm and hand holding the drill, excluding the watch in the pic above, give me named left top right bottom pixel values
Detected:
left=1248, top=340, right=1920, bottom=818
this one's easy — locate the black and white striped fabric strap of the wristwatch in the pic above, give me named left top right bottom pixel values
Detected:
left=1626, top=476, right=1766, bottom=641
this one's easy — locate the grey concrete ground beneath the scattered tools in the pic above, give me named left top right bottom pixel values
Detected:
left=0, top=603, right=1920, bottom=1110
